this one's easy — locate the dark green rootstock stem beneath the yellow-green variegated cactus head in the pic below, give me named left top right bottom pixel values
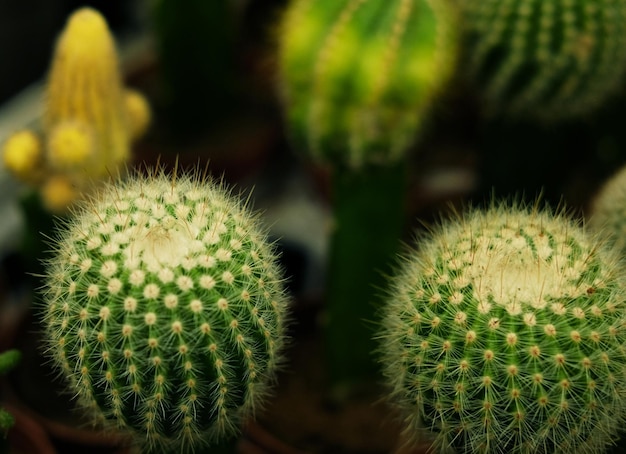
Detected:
left=325, top=162, right=408, bottom=389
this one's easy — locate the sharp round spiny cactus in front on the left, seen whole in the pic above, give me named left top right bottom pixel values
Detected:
left=43, top=168, right=287, bottom=452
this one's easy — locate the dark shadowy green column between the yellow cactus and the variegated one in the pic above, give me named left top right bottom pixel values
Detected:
left=151, top=0, right=239, bottom=138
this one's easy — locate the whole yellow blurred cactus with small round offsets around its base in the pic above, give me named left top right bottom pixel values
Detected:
left=4, top=8, right=150, bottom=212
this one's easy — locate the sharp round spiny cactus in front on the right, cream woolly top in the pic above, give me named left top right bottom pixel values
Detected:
left=381, top=205, right=626, bottom=454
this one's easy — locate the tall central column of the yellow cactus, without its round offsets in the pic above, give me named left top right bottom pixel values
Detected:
left=43, top=8, right=130, bottom=177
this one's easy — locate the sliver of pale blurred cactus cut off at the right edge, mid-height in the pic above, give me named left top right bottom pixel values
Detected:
left=589, top=167, right=626, bottom=256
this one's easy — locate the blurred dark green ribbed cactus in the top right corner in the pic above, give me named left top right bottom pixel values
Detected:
left=461, top=0, right=626, bottom=119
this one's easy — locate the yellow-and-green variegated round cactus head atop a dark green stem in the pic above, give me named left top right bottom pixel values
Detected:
left=279, top=0, right=457, bottom=168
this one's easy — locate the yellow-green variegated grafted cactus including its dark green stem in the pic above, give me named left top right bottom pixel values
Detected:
left=278, top=0, right=456, bottom=389
